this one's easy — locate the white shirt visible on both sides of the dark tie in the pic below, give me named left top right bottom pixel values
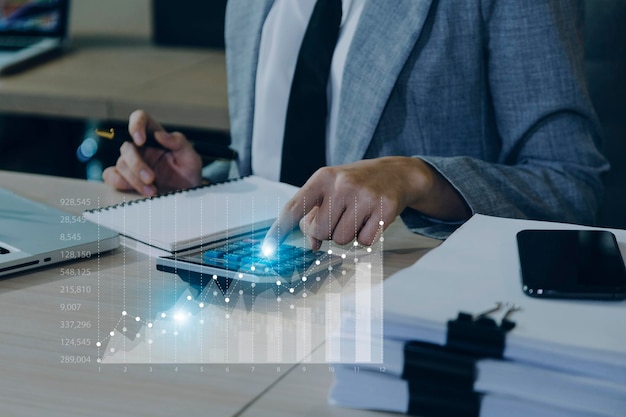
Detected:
left=252, top=0, right=366, bottom=181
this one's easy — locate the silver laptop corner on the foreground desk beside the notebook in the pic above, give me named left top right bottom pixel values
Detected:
left=0, top=188, right=119, bottom=276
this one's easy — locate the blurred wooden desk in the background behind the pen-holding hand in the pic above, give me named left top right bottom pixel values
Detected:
left=0, top=34, right=229, bottom=131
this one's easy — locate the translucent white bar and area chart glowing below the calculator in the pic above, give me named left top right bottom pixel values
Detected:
left=95, top=237, right=383, bottom=364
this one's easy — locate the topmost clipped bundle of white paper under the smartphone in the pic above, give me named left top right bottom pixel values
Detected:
left=384, top=215, right=626, bottom=385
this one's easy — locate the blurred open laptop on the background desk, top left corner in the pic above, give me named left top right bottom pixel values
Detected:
left=0, top=0, right=70, bottom=75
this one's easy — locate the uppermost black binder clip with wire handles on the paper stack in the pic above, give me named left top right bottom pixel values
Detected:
left=446, top=302, right=520, bottom=359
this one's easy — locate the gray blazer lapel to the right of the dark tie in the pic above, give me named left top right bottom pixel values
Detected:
left=330, top=0, right=431, bottom=165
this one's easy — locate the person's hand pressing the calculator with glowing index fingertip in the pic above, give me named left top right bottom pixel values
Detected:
left=264, top=157, right=471, bottom=251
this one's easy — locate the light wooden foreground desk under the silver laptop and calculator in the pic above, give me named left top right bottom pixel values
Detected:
left=0, top=172, right=438, bottom=417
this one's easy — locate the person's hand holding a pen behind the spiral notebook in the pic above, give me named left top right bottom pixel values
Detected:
left=102, top=110, right=202, bottom=196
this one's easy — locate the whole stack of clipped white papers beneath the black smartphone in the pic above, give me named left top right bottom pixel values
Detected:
left=329, top=215, right=626, bottom=417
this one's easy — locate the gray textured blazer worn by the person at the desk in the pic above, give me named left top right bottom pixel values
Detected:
left=226, top=0, right=608, bottom=237
